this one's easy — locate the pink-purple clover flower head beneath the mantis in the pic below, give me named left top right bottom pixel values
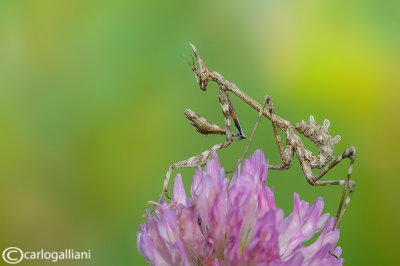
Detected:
left=137, top=150, right=343, bottom=265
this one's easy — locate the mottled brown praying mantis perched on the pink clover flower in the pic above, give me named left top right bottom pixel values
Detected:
left=163, top=44, right=356, bottom=230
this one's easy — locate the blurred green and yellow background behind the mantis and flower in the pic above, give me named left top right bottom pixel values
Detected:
left=0, top=0, right=400, bottom=265
